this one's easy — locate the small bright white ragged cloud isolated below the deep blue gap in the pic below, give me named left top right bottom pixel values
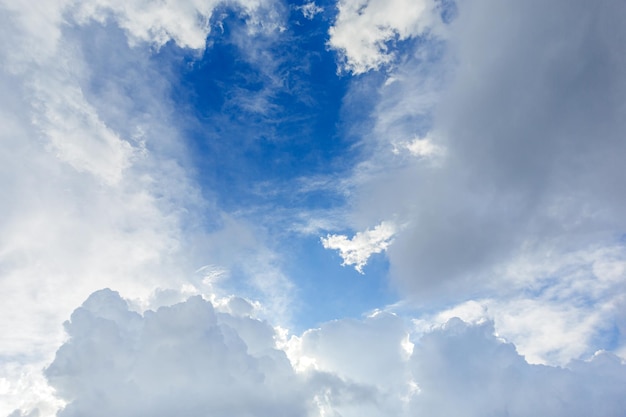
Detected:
left=321, top=221, right=397, bottom=274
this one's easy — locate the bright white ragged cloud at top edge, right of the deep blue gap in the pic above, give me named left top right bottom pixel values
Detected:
left=328, top=0, right=439, bottom=74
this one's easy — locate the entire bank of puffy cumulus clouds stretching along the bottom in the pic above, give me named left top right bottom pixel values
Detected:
left=14, top=290, right=626, bottom=417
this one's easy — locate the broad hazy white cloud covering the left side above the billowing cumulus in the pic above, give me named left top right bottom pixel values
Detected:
left=0, top=1, right=289, bottom=415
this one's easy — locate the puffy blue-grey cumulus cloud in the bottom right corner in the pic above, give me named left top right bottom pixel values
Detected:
left=411, top=319, right=626, bottom=416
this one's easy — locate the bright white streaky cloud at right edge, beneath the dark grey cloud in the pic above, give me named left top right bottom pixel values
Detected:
left=398, top=242, right=626, bottom=366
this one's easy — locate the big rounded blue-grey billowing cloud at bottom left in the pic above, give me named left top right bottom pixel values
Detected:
left=46, top=290, right=307, bottom=416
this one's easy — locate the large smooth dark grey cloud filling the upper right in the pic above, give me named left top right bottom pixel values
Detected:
left=348, top=0, right=626, bottom=302
